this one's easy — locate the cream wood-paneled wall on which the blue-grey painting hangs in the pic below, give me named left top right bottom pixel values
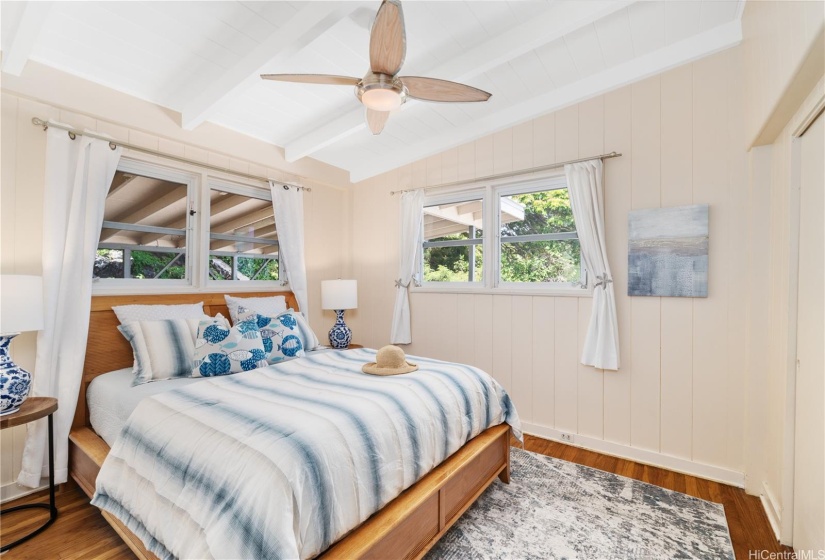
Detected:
left=348, top=49, right=749, bottom=484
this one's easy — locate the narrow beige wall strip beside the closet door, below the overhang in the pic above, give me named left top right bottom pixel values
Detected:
left=746, top=75, right=825, bottom=544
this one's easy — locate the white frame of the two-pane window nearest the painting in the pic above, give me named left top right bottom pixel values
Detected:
left=412, top=171, right=592, bottom=297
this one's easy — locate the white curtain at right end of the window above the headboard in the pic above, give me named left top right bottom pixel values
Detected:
left=269, top=181, right=309, bottom=318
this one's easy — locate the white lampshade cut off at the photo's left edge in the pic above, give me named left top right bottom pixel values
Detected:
left=0, top=274, right=43, bottom=334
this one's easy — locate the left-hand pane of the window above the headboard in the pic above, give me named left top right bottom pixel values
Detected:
left=94, top=170, right=189, bottom=279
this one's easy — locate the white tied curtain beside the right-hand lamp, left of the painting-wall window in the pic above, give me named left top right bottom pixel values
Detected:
left=390, top=189, right=424, bottom=344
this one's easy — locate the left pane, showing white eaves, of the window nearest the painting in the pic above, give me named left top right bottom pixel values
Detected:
left=423, top=198, right=484, bottom=283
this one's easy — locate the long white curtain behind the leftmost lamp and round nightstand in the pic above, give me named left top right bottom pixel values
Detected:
left=17, top=128, right=122, bottom=488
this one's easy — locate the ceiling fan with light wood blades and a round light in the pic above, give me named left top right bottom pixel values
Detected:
left=261, top=0, right=491, bottom=134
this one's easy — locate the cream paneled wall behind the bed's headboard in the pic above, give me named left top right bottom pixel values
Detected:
left=0, top=91, right=349, bottom=498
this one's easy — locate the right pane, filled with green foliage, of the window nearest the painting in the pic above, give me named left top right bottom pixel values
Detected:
left=500, top=188, right=581, bottom=283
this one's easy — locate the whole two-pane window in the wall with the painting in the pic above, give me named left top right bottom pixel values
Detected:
left=420, top=176, right=586, bottom=290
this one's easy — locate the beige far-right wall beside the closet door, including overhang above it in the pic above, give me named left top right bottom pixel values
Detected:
left=741, top=1, right=825, bottom=544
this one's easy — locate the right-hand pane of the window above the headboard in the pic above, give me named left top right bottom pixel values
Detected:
left=209, top=190, right=279, bottom=281
